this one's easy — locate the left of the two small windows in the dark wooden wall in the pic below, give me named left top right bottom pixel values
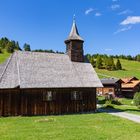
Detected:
left=43, top=91, right=56, bottom=101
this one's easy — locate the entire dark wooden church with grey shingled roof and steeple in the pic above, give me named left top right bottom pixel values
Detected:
left=0, top=21, right=102, bottom=116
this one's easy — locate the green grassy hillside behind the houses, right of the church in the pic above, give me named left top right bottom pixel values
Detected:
left=96, top=59, right=140, bottom=78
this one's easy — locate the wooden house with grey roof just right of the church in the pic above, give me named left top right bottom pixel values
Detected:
left=97, top=78, right=122, bottom=97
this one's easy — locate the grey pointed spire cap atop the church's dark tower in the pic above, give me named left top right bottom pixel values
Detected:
left=65, top=15, right=84, bottom=42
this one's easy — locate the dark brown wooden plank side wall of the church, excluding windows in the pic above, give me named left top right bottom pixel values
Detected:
left=0, top=88, right=96, bottom=116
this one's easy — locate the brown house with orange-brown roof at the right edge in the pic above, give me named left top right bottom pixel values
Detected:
left=121, top=77, right=140, bottom=98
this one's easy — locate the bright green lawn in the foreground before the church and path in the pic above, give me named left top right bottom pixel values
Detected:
left=0, top=113, right=140, bottom=140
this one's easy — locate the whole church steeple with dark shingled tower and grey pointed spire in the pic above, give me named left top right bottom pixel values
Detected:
left=65, top=17, right=84, bottom=62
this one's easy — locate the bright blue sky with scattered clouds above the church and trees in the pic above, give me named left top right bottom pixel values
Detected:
left=0, top=0, right=140, bottom=55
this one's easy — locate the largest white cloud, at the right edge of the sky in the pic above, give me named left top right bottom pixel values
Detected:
left=120, top=16, right=140, bottom=25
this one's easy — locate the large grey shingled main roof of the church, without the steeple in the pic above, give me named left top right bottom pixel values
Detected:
left=0, top=51, right=102, bottom=89
